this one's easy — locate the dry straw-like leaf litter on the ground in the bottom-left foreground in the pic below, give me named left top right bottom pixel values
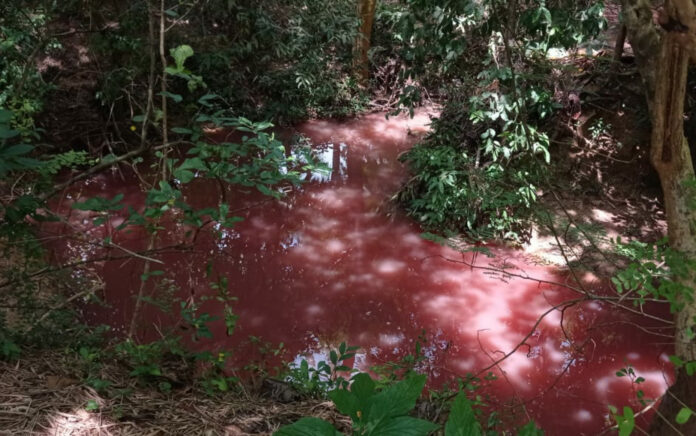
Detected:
left=0, top=351, right=349, bottom=436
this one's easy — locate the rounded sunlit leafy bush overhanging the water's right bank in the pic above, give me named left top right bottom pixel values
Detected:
left=399, top=100, right=542, bottom=240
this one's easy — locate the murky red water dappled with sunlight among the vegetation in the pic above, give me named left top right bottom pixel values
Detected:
left=44, top=109, right=672, bottom=435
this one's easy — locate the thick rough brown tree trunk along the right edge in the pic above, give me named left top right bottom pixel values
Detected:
left=650, top=0, right=696, bottom=435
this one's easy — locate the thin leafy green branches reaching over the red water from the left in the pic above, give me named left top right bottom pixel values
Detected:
left=73, top=111, right=321, bottom=240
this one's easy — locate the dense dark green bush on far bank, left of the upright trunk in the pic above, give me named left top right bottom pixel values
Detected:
left=194, top=0, right=364, bottom=120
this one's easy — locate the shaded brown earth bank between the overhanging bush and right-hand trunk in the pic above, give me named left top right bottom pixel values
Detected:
left=526, top=53, right=666, bottom=277
